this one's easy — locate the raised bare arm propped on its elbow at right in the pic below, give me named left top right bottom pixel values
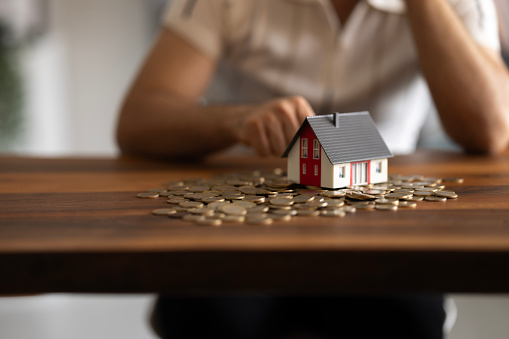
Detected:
left=405, top=0, right=509, bottom=154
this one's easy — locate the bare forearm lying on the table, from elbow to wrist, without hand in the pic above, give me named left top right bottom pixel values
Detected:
left=117, top=93, right=247, bottom=159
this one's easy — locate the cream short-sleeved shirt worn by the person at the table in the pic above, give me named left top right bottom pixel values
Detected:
left=164, top=0, right=500, bottom=154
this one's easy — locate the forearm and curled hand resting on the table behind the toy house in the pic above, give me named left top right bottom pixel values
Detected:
left=117, top=91, right=314, bottom=159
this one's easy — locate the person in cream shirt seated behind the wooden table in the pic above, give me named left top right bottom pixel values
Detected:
left=117, top=0, right=509, bottom=338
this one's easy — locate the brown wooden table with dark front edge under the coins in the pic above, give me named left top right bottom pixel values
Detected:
left=0, top=152, right=509, bottom=294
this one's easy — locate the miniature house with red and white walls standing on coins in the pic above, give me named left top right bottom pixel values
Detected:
left=282, top=112, right=392, bottom=188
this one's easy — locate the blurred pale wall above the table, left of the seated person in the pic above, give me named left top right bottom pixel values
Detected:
left=17, top=0, right=153, bottom=155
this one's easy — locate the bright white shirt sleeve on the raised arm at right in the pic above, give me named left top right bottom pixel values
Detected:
left=450, top=0, right=500, bottom=52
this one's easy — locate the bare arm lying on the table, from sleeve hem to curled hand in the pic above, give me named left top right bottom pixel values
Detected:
left=117, top=29, right=314, bottom=158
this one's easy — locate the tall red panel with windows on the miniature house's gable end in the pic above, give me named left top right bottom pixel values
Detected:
left=299, top=125, right=322, bottom=186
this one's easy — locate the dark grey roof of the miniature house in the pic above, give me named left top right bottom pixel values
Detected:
left=281, top=112, right=392, bottom=164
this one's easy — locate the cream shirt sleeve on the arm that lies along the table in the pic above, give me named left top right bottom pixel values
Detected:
left=163, top=0, right=224, bottom=59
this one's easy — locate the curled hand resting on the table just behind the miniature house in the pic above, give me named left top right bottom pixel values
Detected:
left=238, top=96, right=315, bottom=156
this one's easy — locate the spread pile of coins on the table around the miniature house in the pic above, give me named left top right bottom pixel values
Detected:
left=137, top=169, right=463, bottom=226
